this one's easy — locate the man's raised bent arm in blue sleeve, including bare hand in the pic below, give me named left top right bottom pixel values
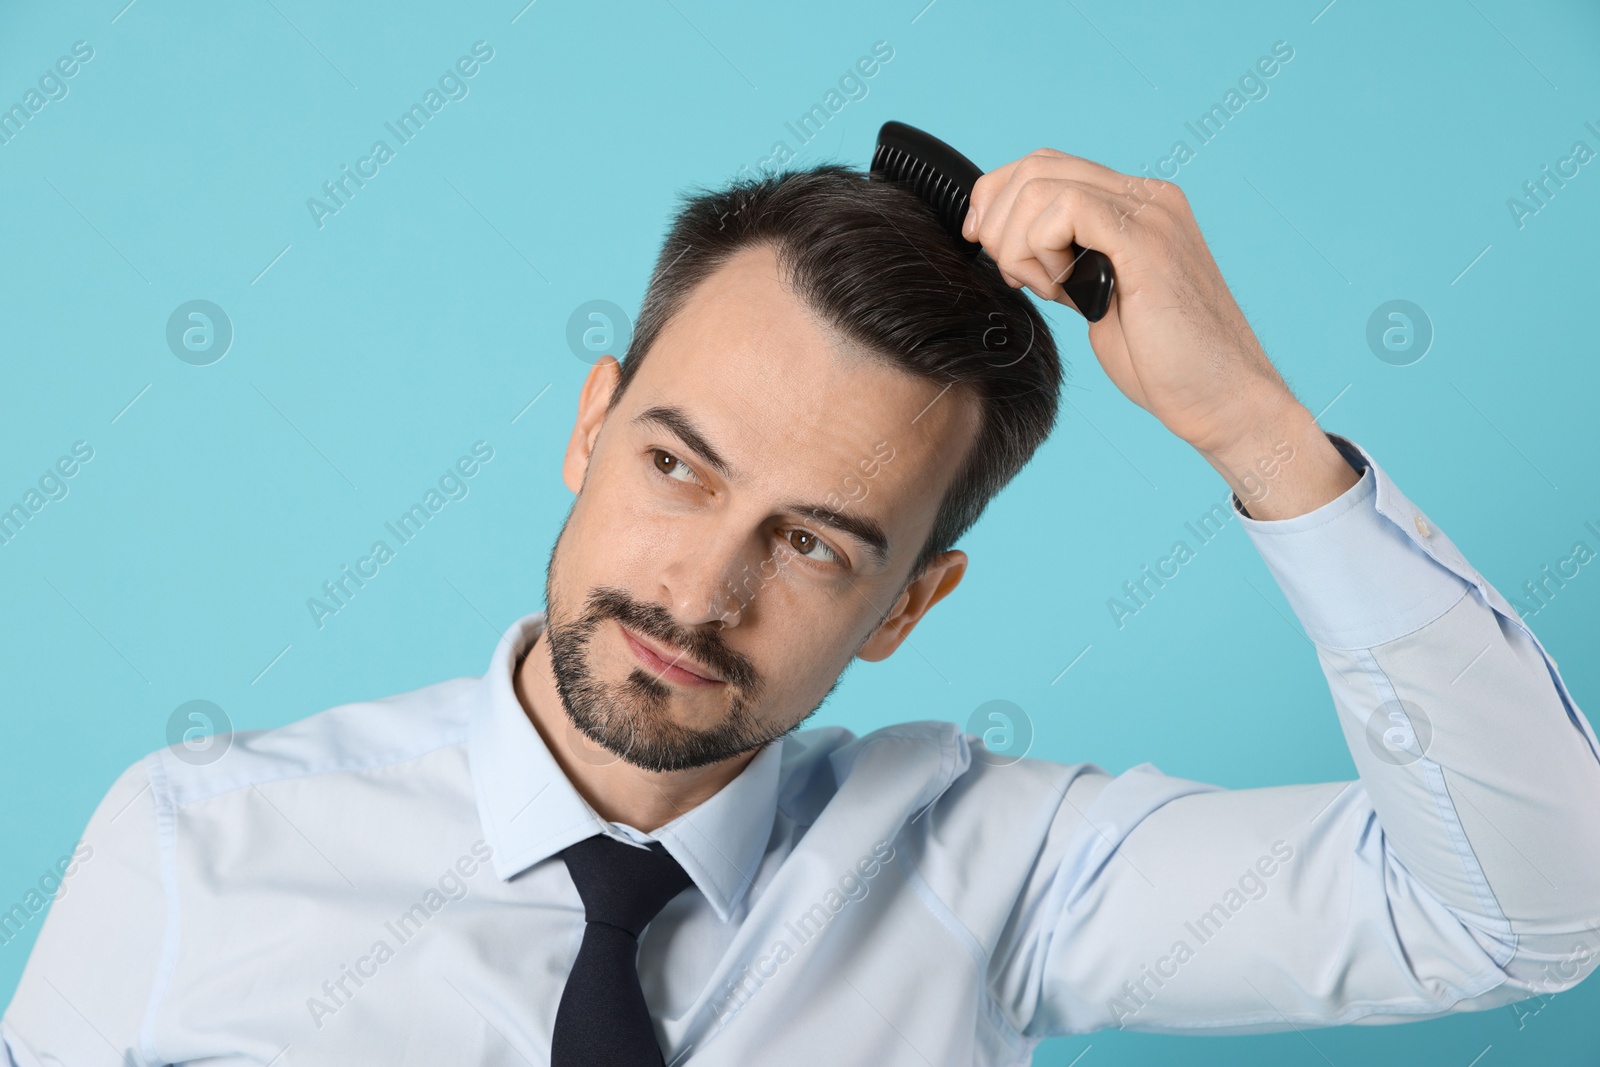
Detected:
left=966, top=149, right=1600, bottom=1037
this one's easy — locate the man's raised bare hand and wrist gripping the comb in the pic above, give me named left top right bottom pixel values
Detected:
left=963, top=149, right=1357, bottom=518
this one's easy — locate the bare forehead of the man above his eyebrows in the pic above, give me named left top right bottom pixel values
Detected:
left=621, top=245, right=976, bottom=566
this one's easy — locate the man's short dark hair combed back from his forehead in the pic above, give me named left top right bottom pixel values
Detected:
left=610, top=163, right=1062, bottom=584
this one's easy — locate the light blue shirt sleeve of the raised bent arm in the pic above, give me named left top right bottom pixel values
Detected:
left=990, top=434, right=1600, bottom=1038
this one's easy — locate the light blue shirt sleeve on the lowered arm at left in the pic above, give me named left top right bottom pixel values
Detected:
left=0, top=760, right=170, bottom=1067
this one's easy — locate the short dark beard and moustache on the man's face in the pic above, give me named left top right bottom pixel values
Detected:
left=542, top=502, right=859, bottom=771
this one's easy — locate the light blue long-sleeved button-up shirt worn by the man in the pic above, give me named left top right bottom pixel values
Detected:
left=0, top=435, right=1600, bottom=1067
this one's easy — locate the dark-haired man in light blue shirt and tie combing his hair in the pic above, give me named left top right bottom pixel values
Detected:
left=9, top=149, right=1600, bottom=1067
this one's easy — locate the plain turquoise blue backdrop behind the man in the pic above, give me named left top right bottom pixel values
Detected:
left=0, top=0, right=1600, bottom=1067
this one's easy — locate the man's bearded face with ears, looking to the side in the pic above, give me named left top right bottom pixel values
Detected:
left=546, top=246, right=976, bottom=771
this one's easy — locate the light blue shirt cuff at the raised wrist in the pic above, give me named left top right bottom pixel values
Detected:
left=1232, top=434, right=1472, bottom=649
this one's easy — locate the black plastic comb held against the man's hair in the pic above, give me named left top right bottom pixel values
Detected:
left=872, top=122, right=1117, bottom=322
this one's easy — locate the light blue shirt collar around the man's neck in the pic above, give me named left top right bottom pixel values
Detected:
left=467, top=611, right=782, bottom=921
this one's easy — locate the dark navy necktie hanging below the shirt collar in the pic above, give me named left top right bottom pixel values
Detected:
left=550, top=833, right=693, bottom=1067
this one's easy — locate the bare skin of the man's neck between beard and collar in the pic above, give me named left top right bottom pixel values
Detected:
left=514, top=632, right=755, bottom=833
